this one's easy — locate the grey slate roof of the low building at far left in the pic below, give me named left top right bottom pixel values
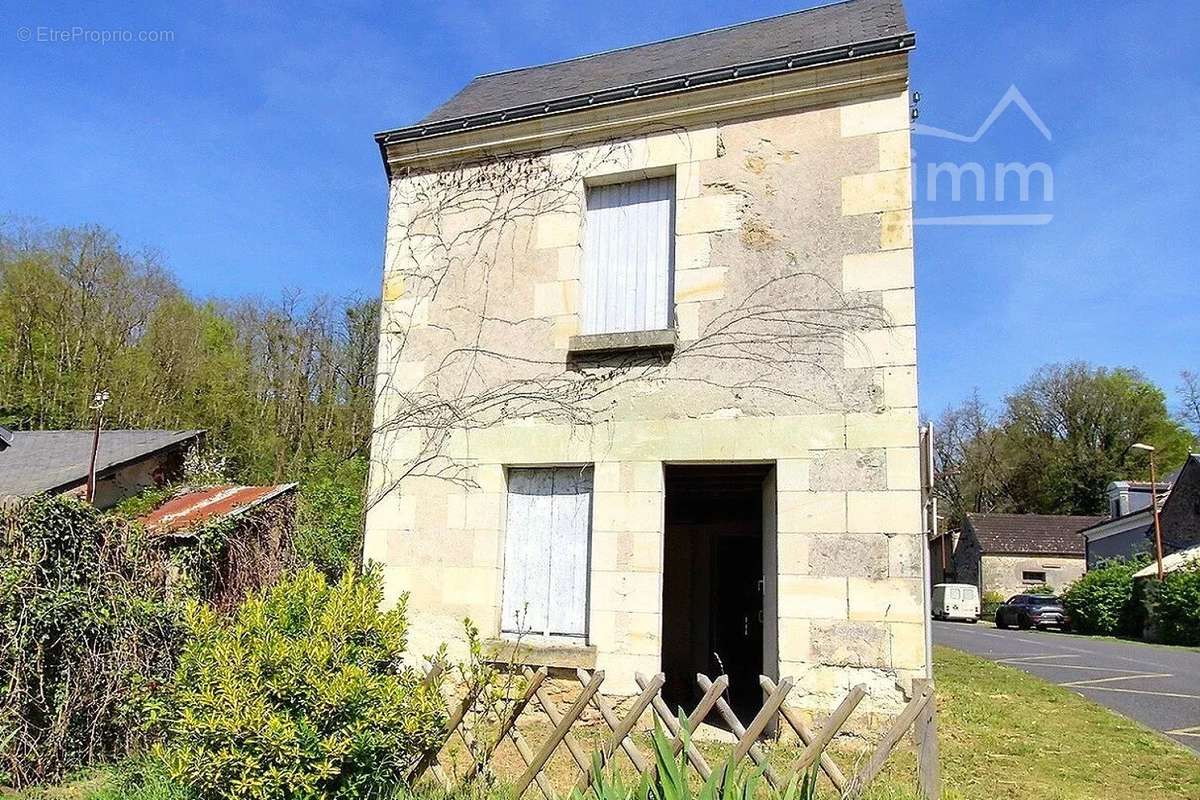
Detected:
left=0, top=431, right=204, bottom=498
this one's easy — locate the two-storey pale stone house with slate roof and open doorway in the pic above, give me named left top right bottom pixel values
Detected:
left=365, top=0, right=930, bottom=714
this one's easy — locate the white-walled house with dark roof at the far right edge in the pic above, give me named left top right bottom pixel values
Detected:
left=1082, top=453, right=1200, bottom=570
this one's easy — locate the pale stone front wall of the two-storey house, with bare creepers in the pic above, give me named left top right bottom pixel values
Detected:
left=365, top=55, right=929, bottom=714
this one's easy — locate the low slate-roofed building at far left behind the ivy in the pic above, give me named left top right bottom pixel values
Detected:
left=0, top=431, right=204, bottom=509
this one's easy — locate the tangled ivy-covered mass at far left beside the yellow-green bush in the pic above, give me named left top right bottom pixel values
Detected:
left=0, top=497, right=181, bottom=787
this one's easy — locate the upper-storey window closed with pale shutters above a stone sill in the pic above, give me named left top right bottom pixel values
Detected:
left=581, top=178, right=674, bottom=333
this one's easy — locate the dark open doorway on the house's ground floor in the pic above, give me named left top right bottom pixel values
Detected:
left=662, top=464, right=772, bottom=724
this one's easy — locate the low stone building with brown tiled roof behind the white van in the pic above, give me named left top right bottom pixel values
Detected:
left=930, top=513, right=1104, bottom=597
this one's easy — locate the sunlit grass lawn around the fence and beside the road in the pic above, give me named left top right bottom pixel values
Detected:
left=11, top=648, right=1200, bottom=800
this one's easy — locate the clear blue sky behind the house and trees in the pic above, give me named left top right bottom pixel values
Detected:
left=0, top=0, right=1200, bottom=413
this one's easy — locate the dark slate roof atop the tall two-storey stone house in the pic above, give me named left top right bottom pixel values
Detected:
left=376, top=0, right=914, bottom=143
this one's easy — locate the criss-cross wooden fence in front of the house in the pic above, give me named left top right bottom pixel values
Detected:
left=408, top=667, right=941, bottom=800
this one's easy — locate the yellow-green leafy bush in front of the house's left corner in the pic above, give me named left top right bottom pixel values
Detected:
left=149, top=567, right=445, bottom=800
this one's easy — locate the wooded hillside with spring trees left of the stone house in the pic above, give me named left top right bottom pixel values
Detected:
left=0, top=224, right=378, bottom=481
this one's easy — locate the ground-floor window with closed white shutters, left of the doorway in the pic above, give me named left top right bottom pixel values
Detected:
left=500, top=467, right=592, bottom=637
